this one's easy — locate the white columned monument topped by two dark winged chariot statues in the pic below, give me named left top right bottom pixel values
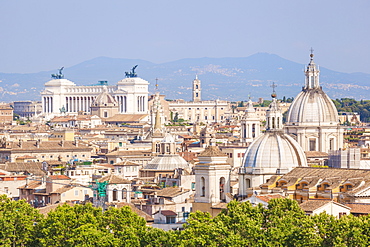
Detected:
left=41, top=69, right=149, bottom=115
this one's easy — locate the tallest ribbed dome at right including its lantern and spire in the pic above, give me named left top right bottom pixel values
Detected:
left=286, top=54, right=338, bottom=126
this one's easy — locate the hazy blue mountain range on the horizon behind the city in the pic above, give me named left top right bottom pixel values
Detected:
left=0, top=53, right=370, bottom=102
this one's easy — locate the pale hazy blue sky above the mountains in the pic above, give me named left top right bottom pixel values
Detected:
left=0, top=0, right=370, bottom=73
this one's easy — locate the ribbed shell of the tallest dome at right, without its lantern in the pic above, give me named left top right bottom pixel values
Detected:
left=286, top=88, right=338, bottom=125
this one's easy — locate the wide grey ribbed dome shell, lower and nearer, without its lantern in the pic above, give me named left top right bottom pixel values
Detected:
left=243, top=130, right=307, bottom=174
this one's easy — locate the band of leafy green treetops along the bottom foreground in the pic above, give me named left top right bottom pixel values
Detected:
left=0, top=196, right=370, bottom=247
